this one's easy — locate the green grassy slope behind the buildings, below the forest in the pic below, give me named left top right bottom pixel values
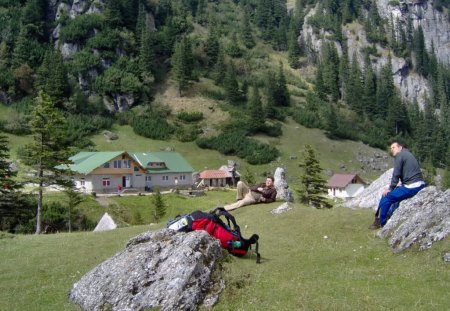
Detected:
left=92, top=120, right=383, bottom=185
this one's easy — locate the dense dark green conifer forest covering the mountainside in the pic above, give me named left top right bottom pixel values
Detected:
left=0, top=0, right=450, bottom=233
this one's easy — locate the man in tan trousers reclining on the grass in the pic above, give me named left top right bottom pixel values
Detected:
left=224, top=176, right=277, bottom=211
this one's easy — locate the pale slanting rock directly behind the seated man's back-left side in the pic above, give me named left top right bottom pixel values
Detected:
left=341, top=168, right=393, bottom=209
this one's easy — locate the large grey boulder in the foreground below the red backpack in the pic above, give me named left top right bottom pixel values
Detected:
left=69, top=229, right=226, bottom=311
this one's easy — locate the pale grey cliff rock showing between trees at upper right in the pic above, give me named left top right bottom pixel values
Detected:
left=301, top=0, right=450, bottom=107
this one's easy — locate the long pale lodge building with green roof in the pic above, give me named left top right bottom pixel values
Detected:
left=70, top=151, right=194, bottom=193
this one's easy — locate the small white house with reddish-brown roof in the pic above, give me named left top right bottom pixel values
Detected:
left=327, top=174, right=366, bottom=199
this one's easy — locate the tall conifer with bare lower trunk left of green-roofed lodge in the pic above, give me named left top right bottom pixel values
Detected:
left=23, top=91, right=72, bottom=234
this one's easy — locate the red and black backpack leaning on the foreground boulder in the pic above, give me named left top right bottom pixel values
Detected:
left=167, top=207, right=261, bottom=263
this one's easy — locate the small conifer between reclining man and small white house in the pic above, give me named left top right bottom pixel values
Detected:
left=299, top=145, right=331, bottom=208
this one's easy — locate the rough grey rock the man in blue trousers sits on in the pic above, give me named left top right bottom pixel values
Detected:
left=377, top=186, right=450, bottom=252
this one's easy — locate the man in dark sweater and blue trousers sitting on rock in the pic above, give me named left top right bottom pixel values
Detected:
left=369, top=141, right=425, bottom=229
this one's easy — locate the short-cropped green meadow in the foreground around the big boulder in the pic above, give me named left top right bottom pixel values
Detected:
left=0, top=192, right=450, bottom=311
